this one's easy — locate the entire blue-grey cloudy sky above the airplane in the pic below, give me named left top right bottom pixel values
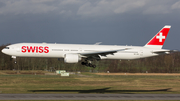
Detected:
left=0, top=0, right=180, bottom=50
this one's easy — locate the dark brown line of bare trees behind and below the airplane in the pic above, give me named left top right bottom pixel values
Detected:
left=0, top=45, right=180, bottom=73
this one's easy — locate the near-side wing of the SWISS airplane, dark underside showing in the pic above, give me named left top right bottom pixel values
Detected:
left=80, top=48, right=130, bottom=57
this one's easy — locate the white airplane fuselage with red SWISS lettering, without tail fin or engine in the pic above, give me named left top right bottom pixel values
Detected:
left=2, top=43, right=167, bottom=60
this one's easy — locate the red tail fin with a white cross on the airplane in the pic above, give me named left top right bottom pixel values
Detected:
left=144, top=25, right=171, bottom=49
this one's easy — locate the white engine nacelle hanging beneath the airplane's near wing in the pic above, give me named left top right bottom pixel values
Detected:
left=64, top=54, right=81, bottom=63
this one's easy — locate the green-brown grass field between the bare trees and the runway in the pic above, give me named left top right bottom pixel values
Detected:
left=0, top=71, right=180, bottom=94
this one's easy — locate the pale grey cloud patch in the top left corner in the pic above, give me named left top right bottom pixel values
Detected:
left=0, top=0, right=57, bottom=15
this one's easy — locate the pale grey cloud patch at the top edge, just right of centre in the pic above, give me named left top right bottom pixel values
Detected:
left=77, top=0, right=145, bottom=16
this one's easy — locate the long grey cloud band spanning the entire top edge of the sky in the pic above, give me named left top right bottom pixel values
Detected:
left=0, top=0, right=180, bottom=18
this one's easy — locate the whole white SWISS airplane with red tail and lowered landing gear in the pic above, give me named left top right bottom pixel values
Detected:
left=2, top=25, right=173, bottom=68
